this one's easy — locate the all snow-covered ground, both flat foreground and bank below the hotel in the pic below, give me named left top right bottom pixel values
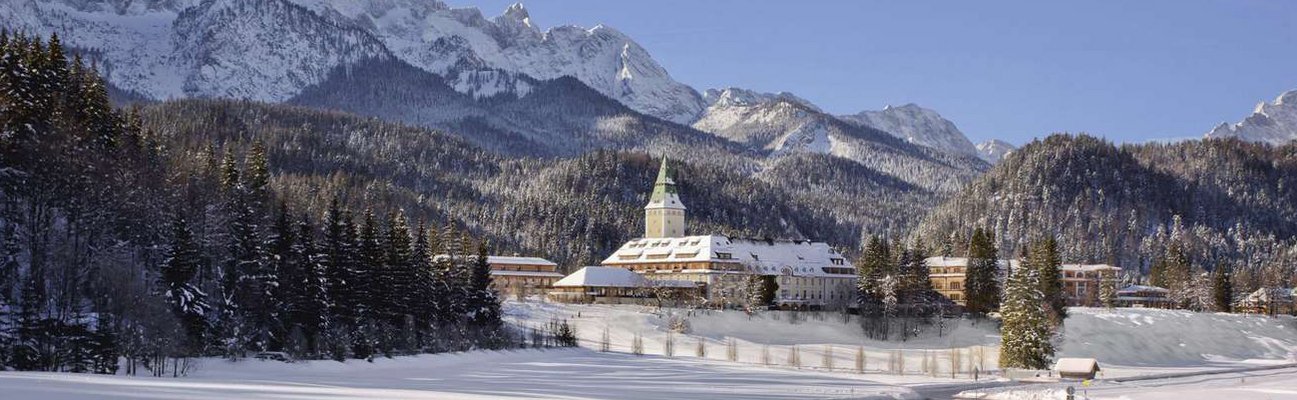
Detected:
left=0, top=301, right=1297, bottom=400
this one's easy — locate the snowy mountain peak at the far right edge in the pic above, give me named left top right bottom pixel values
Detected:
left=1206, top=90, right=1297, bottom=145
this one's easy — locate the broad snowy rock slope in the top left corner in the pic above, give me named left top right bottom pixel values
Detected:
left=0, top=0, right=388, bottom=101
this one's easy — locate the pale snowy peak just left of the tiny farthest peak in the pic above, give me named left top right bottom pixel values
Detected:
left=839, top=104, right=979, bottom=156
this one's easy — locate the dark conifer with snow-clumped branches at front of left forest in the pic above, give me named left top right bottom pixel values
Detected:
left=158, top=216, right=209, bottom=356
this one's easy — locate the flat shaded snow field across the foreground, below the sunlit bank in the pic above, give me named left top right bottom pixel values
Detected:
left=0, top=349, right=939, bottom=400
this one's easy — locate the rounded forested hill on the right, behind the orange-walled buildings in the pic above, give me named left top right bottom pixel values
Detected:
left=916, top=135, right=1297, bottom=284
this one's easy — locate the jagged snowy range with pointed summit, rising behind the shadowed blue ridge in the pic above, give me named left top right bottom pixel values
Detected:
left=254, top=0, right=703, bottom=123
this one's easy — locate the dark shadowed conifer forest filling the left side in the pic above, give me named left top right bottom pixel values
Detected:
left=0, top=34, right=515, bottom=374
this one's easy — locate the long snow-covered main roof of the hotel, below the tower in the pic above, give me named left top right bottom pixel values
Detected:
left=601, top=235, right=856, bottom=277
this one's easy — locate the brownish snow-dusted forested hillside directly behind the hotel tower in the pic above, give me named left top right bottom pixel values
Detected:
left=141, top=100, right=933, bottom=266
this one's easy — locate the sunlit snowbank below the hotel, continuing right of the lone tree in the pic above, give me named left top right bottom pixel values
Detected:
left=506, top=301, right=1297, bottom=379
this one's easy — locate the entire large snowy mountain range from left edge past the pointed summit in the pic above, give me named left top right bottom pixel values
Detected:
left=0, top=0, right=703, bottom=123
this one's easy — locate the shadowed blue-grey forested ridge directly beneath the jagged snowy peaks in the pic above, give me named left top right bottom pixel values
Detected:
left=288, top=60, right=743, bottom=160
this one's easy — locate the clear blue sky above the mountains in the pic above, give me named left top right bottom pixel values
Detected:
left=449, top=0, right=1297, bottom=144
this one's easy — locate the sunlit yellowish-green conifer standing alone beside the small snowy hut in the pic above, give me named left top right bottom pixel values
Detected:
left=1000, top=245, right=1054, bottom=369
